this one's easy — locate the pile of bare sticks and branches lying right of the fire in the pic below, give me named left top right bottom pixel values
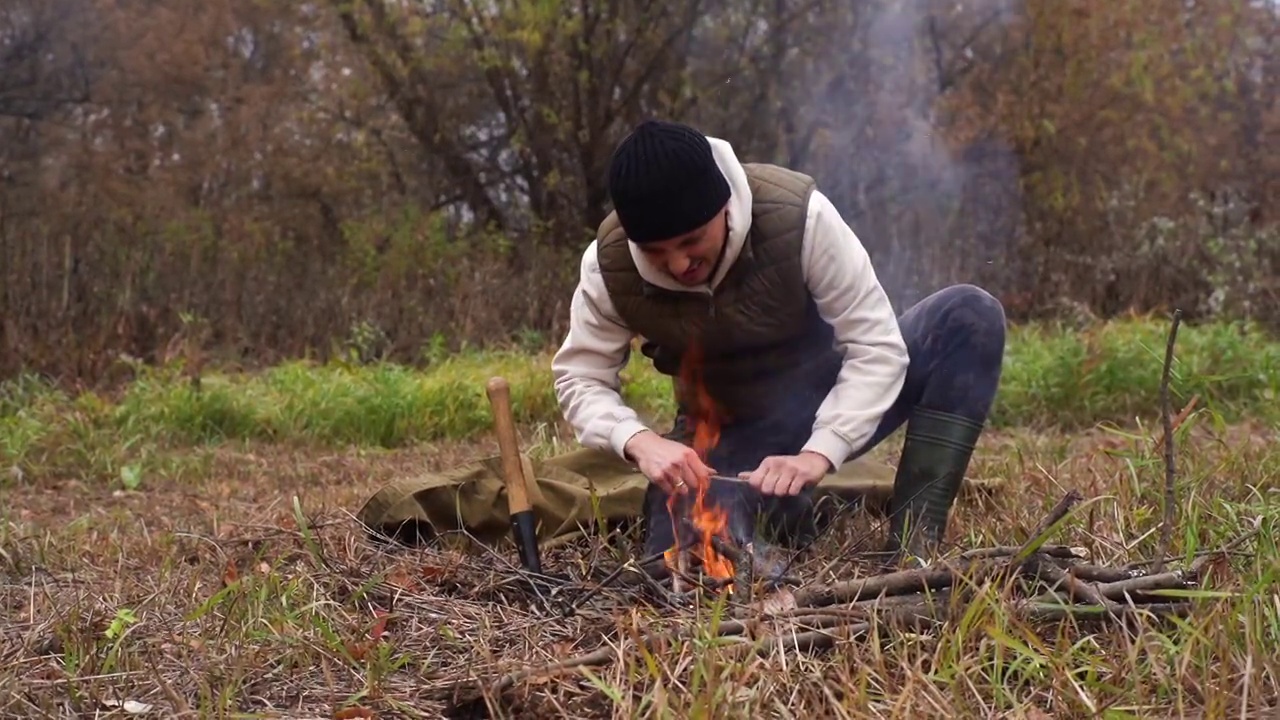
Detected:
left=478, top=481, right=1257, bottom=693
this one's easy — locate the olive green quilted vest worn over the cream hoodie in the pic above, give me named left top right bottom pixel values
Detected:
left=596, top=164, right=842, bottom=419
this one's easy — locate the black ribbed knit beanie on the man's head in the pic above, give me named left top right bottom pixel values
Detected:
left=609, top=120, right=730, bottom=243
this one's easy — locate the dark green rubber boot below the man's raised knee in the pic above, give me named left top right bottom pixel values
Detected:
left=884, top=407, right=983, bottom=564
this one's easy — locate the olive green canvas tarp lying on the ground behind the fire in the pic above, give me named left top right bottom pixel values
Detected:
left=357, top=448, right=993, bottom=544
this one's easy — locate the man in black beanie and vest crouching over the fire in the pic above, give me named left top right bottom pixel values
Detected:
left=552, top=120, right=1005, bottom=566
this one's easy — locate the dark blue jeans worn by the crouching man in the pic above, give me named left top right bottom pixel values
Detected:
left=645, top=284, right=1005, bottom=555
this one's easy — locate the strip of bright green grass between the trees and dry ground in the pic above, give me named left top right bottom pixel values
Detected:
left=0, top=319, right=1280, bottom=478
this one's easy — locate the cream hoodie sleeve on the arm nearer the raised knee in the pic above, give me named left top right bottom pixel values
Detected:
left=801, top=190, right=908, bottom=468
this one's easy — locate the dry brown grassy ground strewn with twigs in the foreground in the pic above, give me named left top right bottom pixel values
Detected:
left=0, top=412, right=1280, bottom=717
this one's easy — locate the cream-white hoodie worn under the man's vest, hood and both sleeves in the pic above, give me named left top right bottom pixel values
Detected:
left=552, top=137, right=908, bottom=468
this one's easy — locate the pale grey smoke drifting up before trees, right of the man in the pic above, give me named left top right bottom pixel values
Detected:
left=820, top=0, right=1020, bottom=309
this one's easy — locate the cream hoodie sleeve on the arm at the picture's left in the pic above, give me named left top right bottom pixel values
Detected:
left=552, top=242, right=649, bottom=459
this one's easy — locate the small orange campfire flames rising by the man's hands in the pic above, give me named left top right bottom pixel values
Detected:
left=666, top=343, right=733, bottom=592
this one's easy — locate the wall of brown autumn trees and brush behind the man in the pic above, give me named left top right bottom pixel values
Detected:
left=0, top=0, right=1280, bottom=379
